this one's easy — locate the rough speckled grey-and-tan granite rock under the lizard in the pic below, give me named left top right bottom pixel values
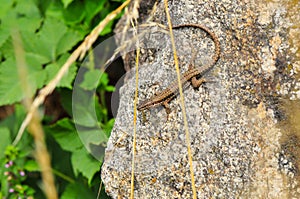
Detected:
left=101, top=0, right=300, bottom=198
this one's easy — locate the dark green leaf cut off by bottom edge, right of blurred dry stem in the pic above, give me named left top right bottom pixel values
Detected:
left=60, top=182, right=95, bottom=199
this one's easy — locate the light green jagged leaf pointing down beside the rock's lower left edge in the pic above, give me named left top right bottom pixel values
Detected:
left=71, top=147, right=100, bottom=184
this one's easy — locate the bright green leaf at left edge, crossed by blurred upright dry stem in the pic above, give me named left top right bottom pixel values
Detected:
left=0, top=55, right=46, bottom=106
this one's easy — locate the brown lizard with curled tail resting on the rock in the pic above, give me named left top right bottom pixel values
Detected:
left=137, top=24, right=221, bottom=113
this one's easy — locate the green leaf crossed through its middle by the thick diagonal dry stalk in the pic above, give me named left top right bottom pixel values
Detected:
left=46, top=54, right=77, bottom=89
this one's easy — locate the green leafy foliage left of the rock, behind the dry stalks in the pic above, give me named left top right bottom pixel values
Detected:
left=0, top=0, right=122, bottom=199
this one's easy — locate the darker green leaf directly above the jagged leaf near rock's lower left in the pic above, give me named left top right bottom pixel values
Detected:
left=46, top=118, right=82, bottom=152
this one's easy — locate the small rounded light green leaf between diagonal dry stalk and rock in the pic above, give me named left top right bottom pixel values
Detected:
left=80, top=69, right=101, bottom=90
